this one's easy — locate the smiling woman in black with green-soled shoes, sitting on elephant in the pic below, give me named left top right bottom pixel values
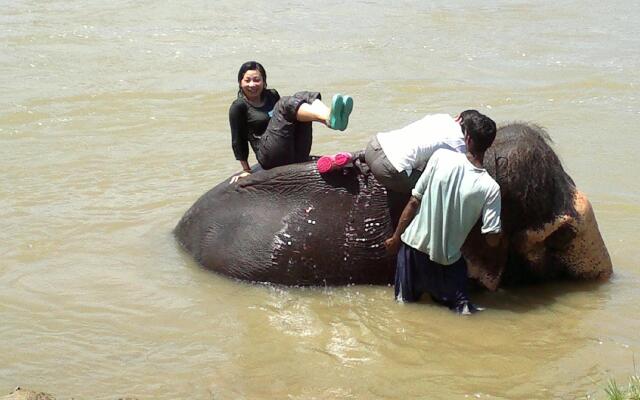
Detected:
left=229, top=61, right=353, bottom=182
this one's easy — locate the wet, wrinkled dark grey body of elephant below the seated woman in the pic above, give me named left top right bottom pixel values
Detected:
left=175, top=161, right=395, bottom=285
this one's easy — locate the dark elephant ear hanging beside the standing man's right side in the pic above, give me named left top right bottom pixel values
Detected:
left=462, top=222, right=508, bottom=291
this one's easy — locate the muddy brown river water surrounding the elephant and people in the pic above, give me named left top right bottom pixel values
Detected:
left=0, top=0, right=640, bottom=399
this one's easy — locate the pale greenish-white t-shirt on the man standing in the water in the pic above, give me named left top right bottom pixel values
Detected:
left=402, top=149, right=501, bottom=265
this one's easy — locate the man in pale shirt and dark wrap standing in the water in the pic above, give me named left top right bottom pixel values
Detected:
left=385, top=110, right=501, bottom=314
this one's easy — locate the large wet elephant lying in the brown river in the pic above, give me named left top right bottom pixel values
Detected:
left=174, top=122, right=612, bottom=290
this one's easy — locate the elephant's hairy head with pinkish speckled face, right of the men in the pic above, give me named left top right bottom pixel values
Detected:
left=464, top=123, right=612, bottom=289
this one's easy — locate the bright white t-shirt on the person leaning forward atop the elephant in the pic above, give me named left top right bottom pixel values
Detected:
left=377, top=114, right=466, bottom=175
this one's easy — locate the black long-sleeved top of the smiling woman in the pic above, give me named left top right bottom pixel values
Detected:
left=229, top=89, right=280, bottom=161
